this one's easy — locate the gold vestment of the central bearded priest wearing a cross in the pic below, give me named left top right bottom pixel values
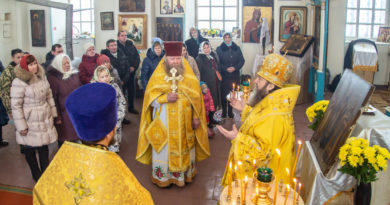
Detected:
left=136, top=59, right=210, bottom=172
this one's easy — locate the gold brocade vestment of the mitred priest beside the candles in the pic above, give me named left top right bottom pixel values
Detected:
left=222, top=85, right=300, bottom=185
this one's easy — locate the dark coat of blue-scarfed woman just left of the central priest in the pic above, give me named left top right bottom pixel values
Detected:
left=141, top=48, right=165, bottom=89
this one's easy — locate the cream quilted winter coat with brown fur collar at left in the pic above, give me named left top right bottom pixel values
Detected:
left=11, top=64, right=57, bottom=147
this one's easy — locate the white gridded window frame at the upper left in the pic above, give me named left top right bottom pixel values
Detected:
left=68, top=0, right=95, bottom=38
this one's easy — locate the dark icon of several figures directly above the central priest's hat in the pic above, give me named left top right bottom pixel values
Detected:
left=157, top=17, right=183, bottom=41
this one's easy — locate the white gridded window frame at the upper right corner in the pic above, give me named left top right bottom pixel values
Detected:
left=344, top=0, right=390, bottom=41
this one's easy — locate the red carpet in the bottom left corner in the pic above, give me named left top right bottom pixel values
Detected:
left=0, top=184, right=32, bottom=205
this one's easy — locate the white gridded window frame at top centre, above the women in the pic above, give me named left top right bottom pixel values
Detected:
left=195, top=0, right=240, bottom=38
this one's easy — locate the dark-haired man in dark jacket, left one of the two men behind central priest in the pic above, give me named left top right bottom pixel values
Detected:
left=100, top=39, right=130, bottom=124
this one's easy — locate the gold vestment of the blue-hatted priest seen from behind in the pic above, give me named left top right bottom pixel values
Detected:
left=33, top=142, right=153, bottom=205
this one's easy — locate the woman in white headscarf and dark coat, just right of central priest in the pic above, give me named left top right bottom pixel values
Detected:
left=196, top=41, right=222, bottom=126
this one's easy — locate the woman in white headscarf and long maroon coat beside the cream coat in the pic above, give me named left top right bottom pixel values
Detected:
left=47, top=54, right=81, bottom=147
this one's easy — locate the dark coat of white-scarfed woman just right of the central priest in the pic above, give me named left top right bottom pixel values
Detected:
left=196, top=52, right=221, bottom=107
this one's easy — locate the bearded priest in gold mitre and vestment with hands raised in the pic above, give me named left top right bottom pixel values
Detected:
left=217, top=54, right=300, bottom=185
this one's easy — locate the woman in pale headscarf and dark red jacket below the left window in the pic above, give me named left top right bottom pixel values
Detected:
left=79, top=43, right=99, bottom=85
